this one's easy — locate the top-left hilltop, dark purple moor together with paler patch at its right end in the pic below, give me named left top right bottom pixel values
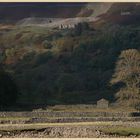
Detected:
left=0, top=3, right=112, bottom=23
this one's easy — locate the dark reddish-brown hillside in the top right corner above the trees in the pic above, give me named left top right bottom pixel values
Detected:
left=95, top=3, right=140, bottom=25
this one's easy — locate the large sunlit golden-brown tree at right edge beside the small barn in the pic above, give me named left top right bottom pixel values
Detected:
left=111, top=49, right=140, bottom=108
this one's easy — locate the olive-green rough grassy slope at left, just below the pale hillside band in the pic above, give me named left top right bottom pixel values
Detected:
left=0, top=26, right=57, bottom=49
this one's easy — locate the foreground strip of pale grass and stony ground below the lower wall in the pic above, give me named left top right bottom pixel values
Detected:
left=0, top=121, right=140, bottom=138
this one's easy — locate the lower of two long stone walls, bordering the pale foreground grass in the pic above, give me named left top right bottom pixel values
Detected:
left=0, top=117, right=140, bottom=124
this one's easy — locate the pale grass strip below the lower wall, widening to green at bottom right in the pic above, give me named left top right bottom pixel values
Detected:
left=0, top=122, right=140, bottom=136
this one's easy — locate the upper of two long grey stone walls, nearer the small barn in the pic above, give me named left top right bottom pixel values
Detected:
left=0, top=111, right=134, bottom=117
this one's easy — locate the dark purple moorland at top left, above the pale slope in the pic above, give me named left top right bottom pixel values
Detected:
left=0, top=3, right=85, bottom=23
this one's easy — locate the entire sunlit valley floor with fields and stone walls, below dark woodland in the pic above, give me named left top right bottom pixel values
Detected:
left=0, top=105, right=140, bottom=138
